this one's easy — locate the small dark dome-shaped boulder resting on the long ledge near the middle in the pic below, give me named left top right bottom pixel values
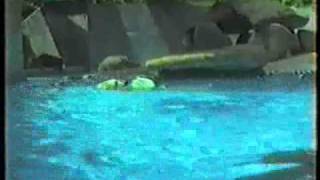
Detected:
left=183, top=23, right=232, bottom=51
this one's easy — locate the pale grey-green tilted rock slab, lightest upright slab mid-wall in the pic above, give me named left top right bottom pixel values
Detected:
left=118, top=4, right=169, bottom=62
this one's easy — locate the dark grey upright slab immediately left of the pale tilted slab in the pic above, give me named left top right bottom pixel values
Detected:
left=88, top=5, right=133, bottom=71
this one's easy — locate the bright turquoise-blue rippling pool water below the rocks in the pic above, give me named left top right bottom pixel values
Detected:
left=7, top=76, right=315, bottom=180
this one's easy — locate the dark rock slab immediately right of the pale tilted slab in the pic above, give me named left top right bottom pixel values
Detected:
left=148, top=1, right=209, bottom=54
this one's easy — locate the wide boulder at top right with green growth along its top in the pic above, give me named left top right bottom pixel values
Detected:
left=209, top=0, right=308, bottom=33
